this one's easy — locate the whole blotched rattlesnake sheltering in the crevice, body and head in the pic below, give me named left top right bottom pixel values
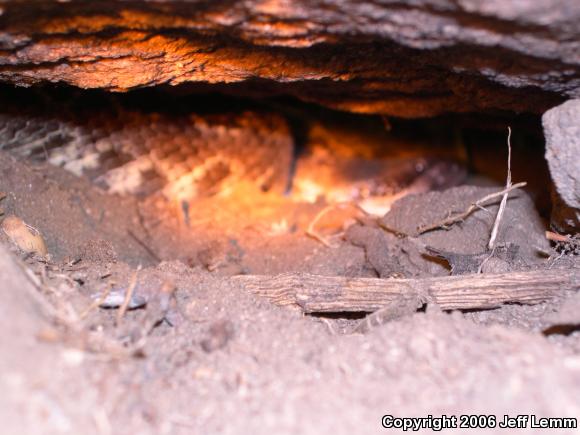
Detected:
left=0, top=88, right=464, bottom=206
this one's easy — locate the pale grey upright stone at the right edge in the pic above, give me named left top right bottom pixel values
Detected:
left=542, top=100, right=580, bottom=231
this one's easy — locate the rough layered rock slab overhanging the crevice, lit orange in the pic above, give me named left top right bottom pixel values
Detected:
left=0, top=0, right=580, bottom=117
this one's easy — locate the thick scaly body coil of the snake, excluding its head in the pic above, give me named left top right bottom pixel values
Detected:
left=0, top=94, right=292, bottom=202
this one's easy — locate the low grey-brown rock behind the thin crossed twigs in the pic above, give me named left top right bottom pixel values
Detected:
left=381, top=186, right=549, bottom=272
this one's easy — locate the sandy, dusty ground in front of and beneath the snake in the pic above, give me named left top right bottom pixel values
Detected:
left=0, top=154, right=580, bottom=434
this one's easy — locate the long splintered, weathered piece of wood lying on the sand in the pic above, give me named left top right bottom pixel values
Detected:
left=232, top=269, right=580, bottom=313
